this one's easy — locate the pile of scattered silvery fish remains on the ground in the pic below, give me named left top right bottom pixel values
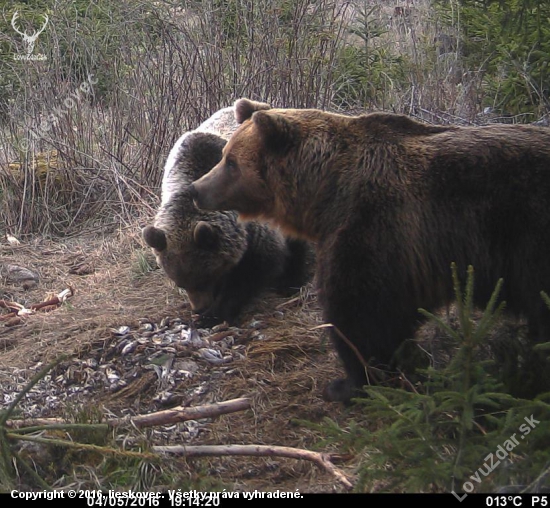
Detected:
left=0, top=318, right=263, bottom=427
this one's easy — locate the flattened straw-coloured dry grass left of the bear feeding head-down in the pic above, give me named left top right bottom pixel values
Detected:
left=0, top=226, right=183, bottom=367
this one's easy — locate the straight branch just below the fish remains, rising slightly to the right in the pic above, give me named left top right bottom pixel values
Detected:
left=7, top=398, right=250, bottom=428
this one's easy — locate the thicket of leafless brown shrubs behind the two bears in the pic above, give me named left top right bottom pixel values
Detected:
left=0, top=0, right=492, bottom=235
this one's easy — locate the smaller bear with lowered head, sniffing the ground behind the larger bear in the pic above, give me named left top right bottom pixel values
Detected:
left=143, top=108, right=312, bottom=325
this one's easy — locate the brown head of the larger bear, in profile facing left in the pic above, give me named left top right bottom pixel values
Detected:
left=191, top=99, right=326, bottom=240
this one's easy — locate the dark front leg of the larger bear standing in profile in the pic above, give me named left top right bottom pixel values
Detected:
left=317, top=229, right=422, bottom=402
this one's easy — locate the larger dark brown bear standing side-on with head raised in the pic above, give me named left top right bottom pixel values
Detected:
left=192, top=99, right=550, bottom=400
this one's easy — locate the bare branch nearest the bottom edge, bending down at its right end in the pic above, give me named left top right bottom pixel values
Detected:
left=151, top=445, right=353, bottom=489
